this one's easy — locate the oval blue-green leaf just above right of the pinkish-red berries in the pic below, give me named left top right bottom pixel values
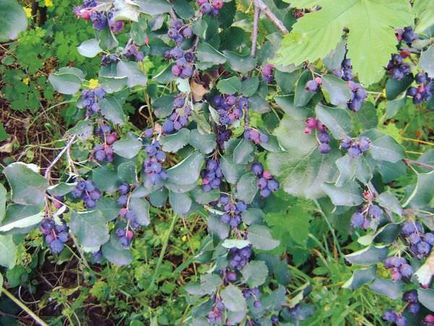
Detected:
left=315, top=104, right=352, bottom=139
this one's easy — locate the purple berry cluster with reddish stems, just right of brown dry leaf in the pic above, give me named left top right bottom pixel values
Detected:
left=213, top=95, right=249, bottom=125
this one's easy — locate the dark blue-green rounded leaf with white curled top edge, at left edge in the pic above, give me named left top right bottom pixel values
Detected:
left=3, top=162, right=48, bottom=205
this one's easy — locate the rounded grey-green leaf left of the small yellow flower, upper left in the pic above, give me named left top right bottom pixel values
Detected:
left=48, top=67, right=84, bottom=95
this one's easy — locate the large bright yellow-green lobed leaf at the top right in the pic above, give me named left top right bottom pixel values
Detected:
left=275, top=0, right=413, bottom=85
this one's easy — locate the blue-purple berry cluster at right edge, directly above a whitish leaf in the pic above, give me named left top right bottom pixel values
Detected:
left=401, top=221, right=434, bottom=259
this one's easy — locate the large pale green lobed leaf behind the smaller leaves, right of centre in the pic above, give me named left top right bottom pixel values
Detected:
left=267, top=116, right=338, bottom=199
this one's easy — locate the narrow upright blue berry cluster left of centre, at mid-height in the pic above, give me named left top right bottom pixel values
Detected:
left=143, top=140, right=167, bottom=186
